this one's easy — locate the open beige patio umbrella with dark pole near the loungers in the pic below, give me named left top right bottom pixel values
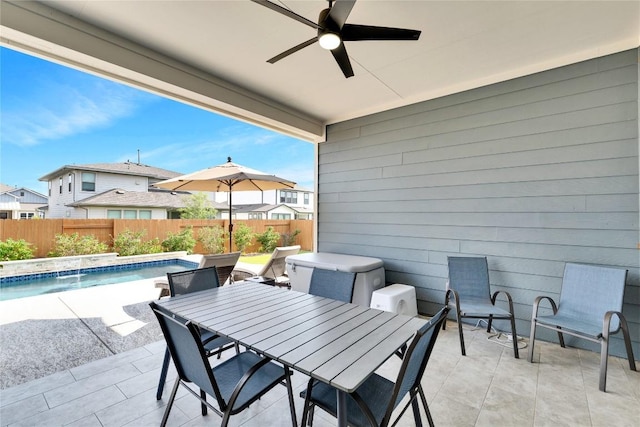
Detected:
left=154, top=157, right=296, bottom=252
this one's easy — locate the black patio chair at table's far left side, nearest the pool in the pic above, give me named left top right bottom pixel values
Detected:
left=156, top=266, right=240, bottom=400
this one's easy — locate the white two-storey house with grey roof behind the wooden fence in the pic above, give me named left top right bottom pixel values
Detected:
left=40, top=162, right=228, bottom=219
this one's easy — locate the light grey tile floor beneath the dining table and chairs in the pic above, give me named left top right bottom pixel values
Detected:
left=0, top=282, right=640, bottom=427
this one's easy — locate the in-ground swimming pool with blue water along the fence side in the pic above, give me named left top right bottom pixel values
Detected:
left=0, top=259, right=198, bottom=301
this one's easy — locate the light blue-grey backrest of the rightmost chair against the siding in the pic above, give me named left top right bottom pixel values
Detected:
left=558, top=263, right=627, bottom=331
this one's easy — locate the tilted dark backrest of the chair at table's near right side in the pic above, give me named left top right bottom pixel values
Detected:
left=382, top=307, right=449, bottom=425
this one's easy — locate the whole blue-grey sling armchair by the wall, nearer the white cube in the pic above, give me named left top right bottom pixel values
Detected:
left=442, top=257, right=520, bottom=359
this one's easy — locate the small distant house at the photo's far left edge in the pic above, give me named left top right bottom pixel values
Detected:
left=0, top=184, right=47, bottom=219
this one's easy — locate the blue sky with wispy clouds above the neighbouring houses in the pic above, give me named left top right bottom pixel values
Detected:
left=0, top=47, right=313, bottom=195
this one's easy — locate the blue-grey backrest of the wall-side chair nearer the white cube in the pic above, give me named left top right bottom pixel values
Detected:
left=448, top=257, right=491, bottom=300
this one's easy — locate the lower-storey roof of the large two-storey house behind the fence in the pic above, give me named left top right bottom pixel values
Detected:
left=69, top=188, right=229, bottom=210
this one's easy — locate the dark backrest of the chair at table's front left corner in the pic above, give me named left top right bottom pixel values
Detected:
left=149, top=301, right=225, bottom=408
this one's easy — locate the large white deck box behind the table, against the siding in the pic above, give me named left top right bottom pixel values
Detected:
left=286, top=252, right=385, bottom=307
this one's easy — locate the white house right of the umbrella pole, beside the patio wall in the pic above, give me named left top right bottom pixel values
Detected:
left=213, top=186, right=314, bottom=219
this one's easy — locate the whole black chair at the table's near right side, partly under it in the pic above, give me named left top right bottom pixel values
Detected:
left=300, top=307, right=449, bottom=427
